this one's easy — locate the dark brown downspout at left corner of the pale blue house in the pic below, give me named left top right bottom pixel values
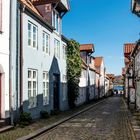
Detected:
left=20, top=5, right=25, bottom=112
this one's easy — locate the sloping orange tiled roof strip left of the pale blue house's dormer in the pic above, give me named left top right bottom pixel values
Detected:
left=19, top=0, right=42, bottom=17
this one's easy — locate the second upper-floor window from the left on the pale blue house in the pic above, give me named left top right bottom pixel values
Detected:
left=42, top=32, right=50, bottom=54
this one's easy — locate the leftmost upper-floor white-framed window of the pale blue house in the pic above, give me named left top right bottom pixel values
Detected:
left=28, top=22, right=37, bottom=49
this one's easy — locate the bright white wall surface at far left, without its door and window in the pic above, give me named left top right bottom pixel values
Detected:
left=0, top=0, right=10, bottom=117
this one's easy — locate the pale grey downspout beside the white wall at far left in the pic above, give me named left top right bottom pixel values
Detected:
left=9, top=1, right=14, bottom=125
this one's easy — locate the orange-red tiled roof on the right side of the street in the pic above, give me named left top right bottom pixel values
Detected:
left=124, top=43, right=135, bottom=54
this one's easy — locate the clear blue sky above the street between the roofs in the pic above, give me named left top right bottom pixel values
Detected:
left=63, top=0, right=140, bottom=75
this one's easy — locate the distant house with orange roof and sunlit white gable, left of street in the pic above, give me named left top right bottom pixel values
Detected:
left=95, top=57, right=105, bottom=98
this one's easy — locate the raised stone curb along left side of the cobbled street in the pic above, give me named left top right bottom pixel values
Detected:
left=16, top=99, right=106, bottom=140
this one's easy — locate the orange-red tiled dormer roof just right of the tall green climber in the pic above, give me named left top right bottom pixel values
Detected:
left=80, top=44, right=94, bottom=53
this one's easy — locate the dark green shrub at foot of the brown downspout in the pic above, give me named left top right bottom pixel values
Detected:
left=20, top=112, right=32, bottom=127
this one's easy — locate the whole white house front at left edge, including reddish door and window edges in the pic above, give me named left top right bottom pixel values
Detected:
left=0, top=0, right=10, bottom=118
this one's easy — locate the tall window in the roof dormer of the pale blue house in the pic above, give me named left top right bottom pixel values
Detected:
left=53, top=11, right=60, bottom=32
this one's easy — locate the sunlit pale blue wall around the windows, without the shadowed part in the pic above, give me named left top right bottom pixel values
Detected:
left=23, top=13, right=66, bottom=106
